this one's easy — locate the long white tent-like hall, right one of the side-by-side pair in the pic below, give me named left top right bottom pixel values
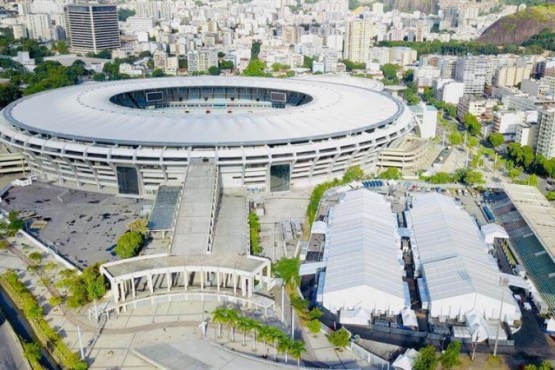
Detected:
left=410, top=193, right=518, bottom=318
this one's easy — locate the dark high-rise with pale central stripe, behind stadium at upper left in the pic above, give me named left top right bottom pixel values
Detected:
left=64, top=4, right=121, bottom=53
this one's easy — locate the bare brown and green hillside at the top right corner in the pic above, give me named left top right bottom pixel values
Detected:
left=478, top=4, right=555, bottom=45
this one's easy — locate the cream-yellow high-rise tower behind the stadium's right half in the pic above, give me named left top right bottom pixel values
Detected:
left=343, top=19, right=374, bottom=63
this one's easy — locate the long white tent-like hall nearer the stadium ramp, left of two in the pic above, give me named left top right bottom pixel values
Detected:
left=324, top=189, right=405, bottom=310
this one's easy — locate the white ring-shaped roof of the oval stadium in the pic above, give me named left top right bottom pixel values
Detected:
left=3, top=77, right=410, bottom=146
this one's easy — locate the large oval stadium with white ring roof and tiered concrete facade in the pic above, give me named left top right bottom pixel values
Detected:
left=0, top=77, right=415, bottom=196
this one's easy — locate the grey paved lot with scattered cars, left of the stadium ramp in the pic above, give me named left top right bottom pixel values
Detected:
left=1, top=183, right=151, bottom=267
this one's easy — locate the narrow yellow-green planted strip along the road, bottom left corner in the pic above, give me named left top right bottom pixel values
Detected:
left=0, top=270, right=87, bottom=370
